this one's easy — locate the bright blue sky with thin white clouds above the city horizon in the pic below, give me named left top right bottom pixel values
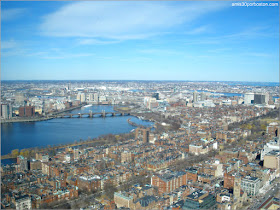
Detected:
left=1, top=1, right=279, bottom=82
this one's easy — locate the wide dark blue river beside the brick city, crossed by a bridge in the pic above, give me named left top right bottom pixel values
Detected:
left=1, top=105, right=153, bottom=163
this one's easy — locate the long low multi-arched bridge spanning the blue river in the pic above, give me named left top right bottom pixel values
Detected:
left=52, top=111, right=130, bottom=118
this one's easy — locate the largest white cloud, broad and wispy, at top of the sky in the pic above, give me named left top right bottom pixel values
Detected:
left=40, top=1, right=230, bottom=39
